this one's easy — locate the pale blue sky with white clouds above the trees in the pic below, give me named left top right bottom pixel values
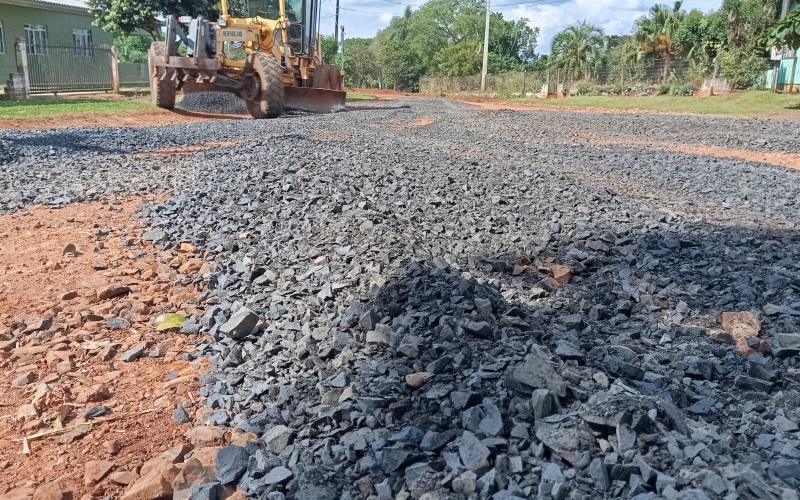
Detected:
left=321, top=0, right=722, bottom=54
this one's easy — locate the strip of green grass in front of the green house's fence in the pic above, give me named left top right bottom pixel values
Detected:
left=0, top=97, right=152, bottom=119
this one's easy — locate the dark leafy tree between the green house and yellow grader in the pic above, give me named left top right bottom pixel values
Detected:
left=86, top=0, right=219, bottom=40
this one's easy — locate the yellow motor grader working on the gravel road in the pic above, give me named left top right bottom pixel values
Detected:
left=148, top=0, right=346, bottom=118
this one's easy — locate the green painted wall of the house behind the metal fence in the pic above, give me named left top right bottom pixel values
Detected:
left=0, top=0, right=113, bottom=80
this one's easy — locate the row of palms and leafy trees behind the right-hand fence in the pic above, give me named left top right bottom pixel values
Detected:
left=549, top=0, right=781, bottom=88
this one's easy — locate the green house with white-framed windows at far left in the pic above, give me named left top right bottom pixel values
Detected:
left=0, top=0, right=113, bottom=81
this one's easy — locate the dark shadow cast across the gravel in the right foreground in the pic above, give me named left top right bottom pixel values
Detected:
left=340, top=219, right=800, bottom=432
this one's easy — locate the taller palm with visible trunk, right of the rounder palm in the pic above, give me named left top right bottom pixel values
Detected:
left=633, top=0, right=686, bottom=82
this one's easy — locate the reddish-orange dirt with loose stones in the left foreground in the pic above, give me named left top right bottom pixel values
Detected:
left=0, top=199, right=212, bottom=500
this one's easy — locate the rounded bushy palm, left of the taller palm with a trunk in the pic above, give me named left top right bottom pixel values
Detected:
left=550, top=21, right=605, bottom=80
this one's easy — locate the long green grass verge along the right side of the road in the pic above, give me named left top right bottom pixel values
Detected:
left=508, top=91, right=800, bottom=117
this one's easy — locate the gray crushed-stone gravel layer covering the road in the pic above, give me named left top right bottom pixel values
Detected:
left=0, top=99, right=800, bottom=500
